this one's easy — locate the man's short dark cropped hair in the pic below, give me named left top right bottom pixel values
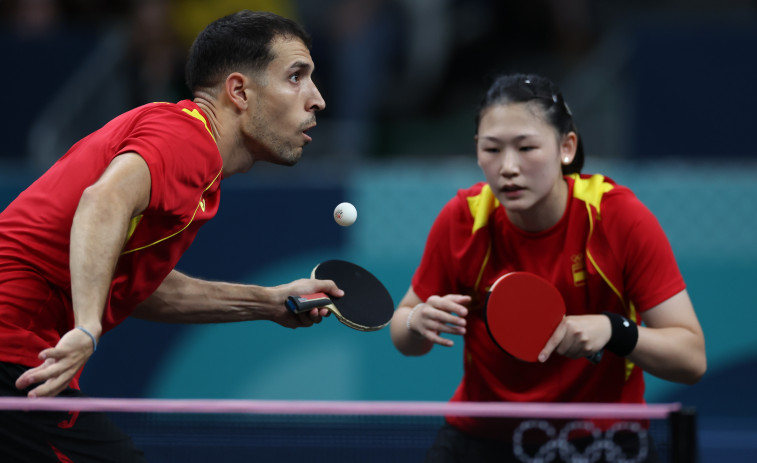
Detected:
left=185, top=10, right=311, bottom=93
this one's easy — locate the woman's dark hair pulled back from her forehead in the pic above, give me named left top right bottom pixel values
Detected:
left=476, top=74, right=584, bottom=175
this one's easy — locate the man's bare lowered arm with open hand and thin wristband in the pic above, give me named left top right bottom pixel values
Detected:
left=16, top=153, right=150, bottom=396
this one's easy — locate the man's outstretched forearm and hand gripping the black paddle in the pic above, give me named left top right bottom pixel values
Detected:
left=132, top=270, right=344, bottom=328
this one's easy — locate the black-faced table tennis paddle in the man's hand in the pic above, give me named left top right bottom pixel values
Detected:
left=286, top=260, right=394, bottom=331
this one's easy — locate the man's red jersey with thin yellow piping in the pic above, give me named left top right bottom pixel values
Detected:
left=0, top=100, right=222, bottom=382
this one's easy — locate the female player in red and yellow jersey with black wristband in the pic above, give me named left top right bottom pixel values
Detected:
left=391, top=74, right=706, bottom=461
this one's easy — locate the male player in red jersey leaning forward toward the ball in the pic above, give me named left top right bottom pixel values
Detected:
left=0, top=11, right=343, bottom=462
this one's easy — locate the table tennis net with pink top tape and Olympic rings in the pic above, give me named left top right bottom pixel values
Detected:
left=0, top=398, right=697, bottom=463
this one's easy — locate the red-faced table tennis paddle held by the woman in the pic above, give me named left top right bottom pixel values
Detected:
left=484, top=272, right=602, bottom=363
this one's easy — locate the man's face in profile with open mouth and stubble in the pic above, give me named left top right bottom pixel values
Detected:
left=245, top=38, right=326, bottom=165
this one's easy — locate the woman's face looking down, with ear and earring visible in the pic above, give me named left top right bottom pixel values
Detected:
left=476, top=103, right=577, bottom=231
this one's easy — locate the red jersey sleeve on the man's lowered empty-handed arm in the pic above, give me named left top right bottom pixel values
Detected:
left=116, top=107, right=221, bottom=215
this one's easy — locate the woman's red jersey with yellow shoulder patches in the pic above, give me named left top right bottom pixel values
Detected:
left=412, top=175, right=685, bottom=435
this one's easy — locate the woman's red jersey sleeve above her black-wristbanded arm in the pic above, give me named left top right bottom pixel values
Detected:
left=603, top=190, right=686, bottom=312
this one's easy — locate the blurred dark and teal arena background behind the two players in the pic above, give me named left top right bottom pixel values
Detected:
left=0, top=0, right=757, bottom=461
